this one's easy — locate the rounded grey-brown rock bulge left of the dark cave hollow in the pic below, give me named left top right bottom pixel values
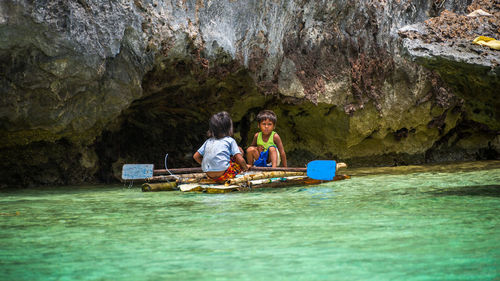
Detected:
left=0, top=1, right=146, bottom=147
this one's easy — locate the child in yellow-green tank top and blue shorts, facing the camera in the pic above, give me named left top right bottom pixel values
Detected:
left=246, top=110, right=287, bottom=167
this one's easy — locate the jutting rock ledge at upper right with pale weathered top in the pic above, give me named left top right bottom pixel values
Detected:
left=399, top=0, right=500, bottom=131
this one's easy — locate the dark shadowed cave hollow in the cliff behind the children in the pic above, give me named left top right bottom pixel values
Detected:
left=95, top=58, right=279, bottom=182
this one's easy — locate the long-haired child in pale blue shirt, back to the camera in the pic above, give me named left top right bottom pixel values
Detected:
left=193, top=111, right=248, bottom=183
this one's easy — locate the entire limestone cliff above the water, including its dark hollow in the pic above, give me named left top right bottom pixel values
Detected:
left=0, top=0, right=500, bottom=186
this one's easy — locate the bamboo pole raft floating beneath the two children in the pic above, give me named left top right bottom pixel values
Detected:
left=142, top=168, right=350, bottom=193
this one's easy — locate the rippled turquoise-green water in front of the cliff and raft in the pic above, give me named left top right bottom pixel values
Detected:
left=0, top=161, right=500, bottom=280
